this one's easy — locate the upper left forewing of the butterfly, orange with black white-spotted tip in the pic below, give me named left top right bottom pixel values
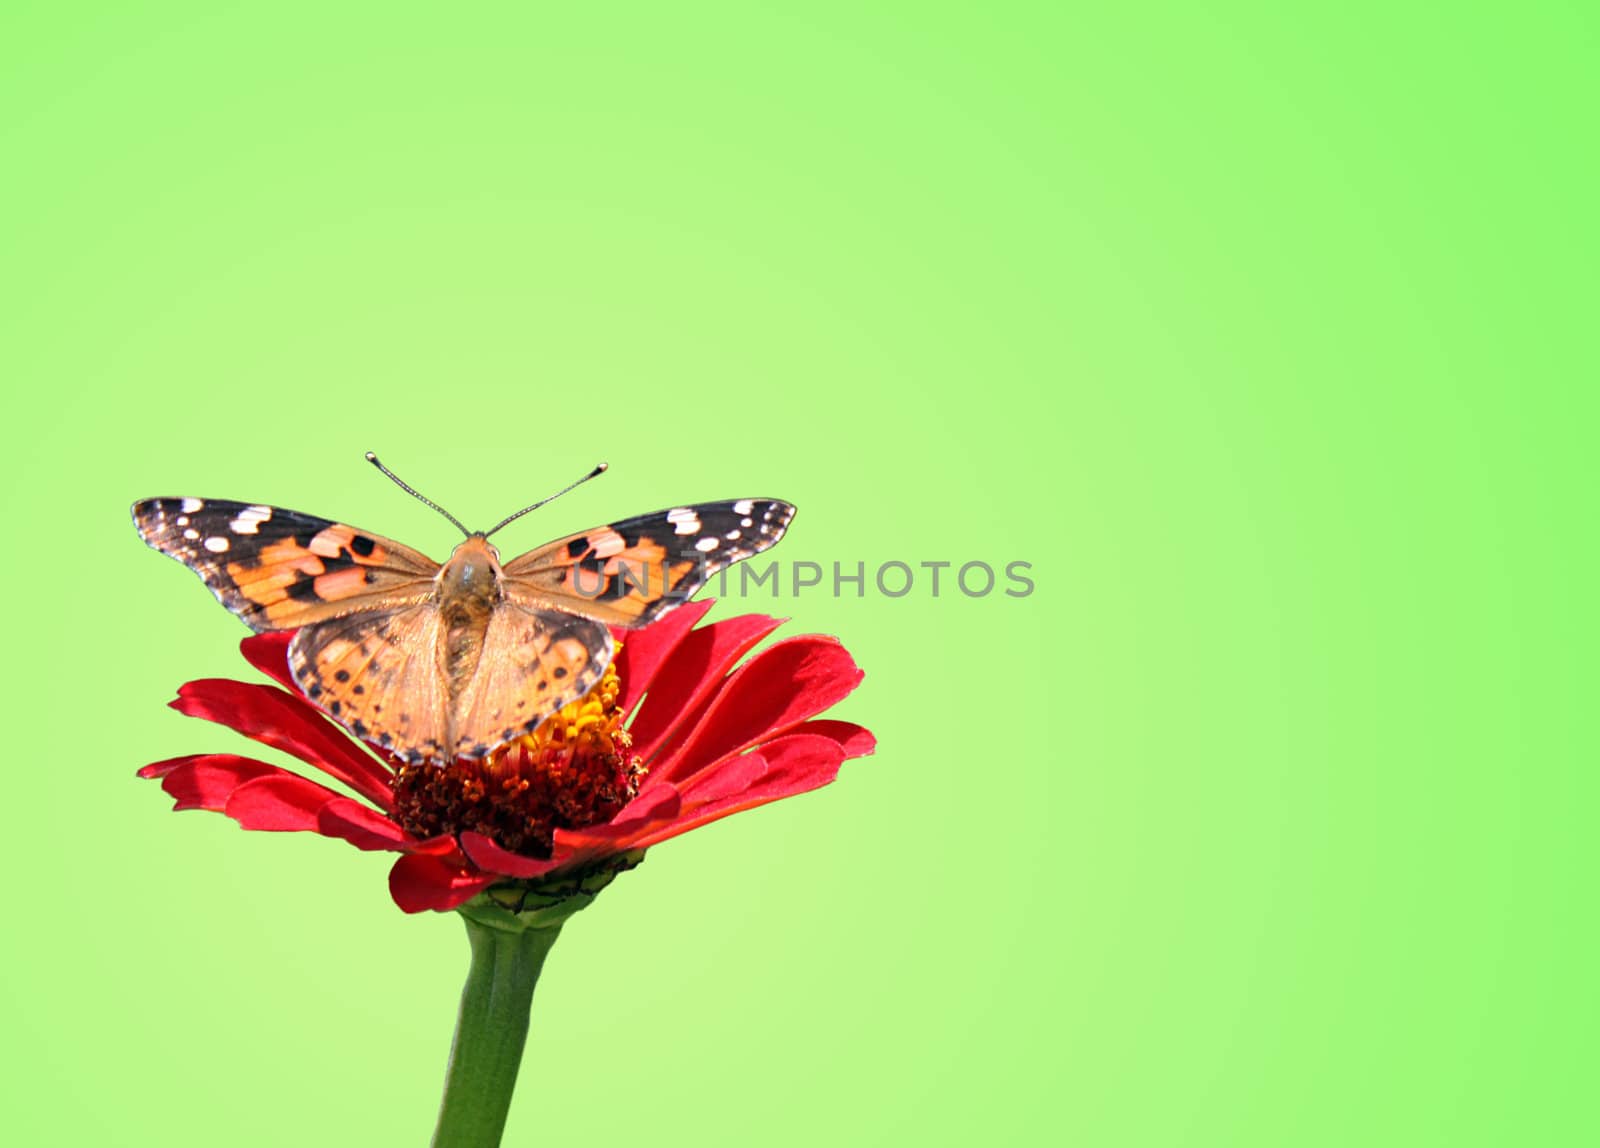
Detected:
left=133, top=499, right=438, bottom=632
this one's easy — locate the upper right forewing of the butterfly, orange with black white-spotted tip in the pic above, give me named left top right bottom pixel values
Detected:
left=502, top=499, right=795, bottom=627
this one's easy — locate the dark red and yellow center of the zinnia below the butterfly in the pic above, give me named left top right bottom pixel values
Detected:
left=392, top=665, right=645, bottom=860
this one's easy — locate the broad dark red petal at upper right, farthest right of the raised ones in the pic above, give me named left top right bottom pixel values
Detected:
left=656, top=633, right=862, bottom=793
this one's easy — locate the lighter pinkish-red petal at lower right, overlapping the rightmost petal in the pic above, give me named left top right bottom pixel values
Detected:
left=626, top=734, right=845, bottom=849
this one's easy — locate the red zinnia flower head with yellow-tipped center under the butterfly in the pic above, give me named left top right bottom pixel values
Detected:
left=139, top=601, right=874, bottom=913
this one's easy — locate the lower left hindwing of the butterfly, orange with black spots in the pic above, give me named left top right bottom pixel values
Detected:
left=290, top=603, right=450, bottom=763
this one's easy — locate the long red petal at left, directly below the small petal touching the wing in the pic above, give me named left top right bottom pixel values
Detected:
left=171, top=678, right=394, bottom=809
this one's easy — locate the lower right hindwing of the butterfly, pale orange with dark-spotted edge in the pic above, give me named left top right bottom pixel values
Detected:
left=453, top=601, right=613, bottom=758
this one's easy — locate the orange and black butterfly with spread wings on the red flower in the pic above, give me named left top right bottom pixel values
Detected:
left=133, top=454, right=795, bottom=764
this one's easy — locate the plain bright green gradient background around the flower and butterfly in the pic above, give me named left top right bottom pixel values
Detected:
left=0, top=3, right=1600, bottom=1148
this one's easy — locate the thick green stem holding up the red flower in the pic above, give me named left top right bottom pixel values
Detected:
left=434, top=913, right=562, bottom=1148
